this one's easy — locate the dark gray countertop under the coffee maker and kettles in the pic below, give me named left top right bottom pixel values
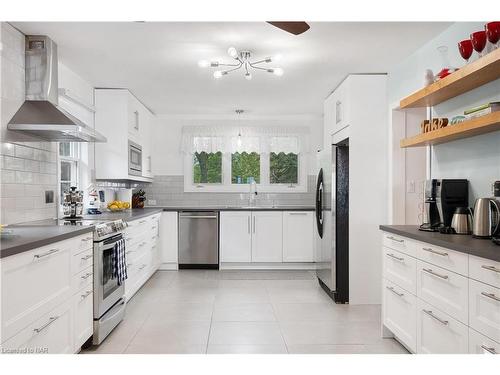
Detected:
left=380, top=225, right=500, bottom=262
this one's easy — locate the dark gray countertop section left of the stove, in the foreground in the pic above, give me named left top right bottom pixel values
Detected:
left=0, top=225, right=94, bottom=258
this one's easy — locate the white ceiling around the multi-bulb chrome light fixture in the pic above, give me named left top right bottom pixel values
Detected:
left=13, top=22, right=449, bottom=115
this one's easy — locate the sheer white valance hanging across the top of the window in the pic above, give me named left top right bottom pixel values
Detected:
left=181, top=126, right=310, bottom=154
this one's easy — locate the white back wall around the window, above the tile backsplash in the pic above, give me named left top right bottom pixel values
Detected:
left=153, top=115, right=323, bottom=175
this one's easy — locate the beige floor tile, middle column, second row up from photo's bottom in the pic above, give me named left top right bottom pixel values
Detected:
left=209, top=322, right=283, bottom=345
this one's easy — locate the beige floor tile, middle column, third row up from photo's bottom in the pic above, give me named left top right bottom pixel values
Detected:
left=212, top=302, right=276, bottom=322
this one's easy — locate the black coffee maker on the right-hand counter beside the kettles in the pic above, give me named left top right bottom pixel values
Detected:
left=419, top=179, right=469, bottom=232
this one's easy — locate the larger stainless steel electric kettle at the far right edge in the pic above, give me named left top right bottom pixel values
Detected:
left=472, top=198, right=500, bottom=238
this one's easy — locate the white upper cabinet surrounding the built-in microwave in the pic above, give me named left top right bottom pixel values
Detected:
left=95, top=89, right=153, bottom=181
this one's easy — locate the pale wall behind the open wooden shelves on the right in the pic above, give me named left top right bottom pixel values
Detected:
left=388, top=22, right=500, bottom=205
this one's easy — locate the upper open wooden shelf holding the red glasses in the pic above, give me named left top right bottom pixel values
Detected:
left=399, top=48, right=500, bottom=109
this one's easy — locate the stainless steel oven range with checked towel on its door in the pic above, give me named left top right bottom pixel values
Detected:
left=92, top=220, right=126, bottom=345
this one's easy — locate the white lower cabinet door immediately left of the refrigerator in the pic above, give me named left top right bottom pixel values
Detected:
left=283, top=211, right=314, bottom=262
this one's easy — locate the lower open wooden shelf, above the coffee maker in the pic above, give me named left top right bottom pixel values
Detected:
left=399, top=112, right=500, bottom=148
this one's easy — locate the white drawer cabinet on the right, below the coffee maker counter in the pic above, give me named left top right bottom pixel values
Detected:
left=382, top=233, right=500, bottom=354
